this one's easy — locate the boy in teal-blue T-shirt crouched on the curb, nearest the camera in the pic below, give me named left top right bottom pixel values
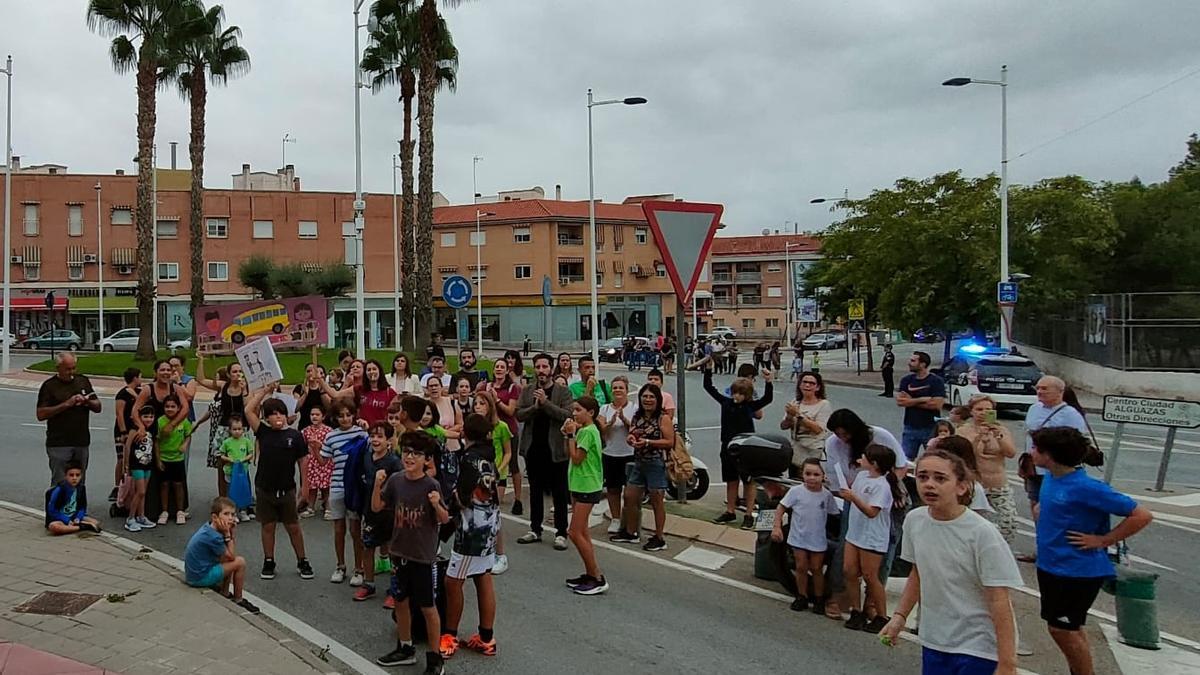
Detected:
left=184, top=497, right=258, bottom=614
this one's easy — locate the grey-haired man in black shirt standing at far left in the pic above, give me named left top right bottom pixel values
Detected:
left=37, top=352, right=100, bottom=485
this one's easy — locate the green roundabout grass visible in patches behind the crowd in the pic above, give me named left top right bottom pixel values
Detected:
left=30, top=350, right=482, bottom=384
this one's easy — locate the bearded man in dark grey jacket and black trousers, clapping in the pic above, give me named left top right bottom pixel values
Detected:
left=517, top=353, right=571, bottom=551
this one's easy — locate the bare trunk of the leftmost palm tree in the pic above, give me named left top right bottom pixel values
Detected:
left=137, top=44, right=158, bottom=360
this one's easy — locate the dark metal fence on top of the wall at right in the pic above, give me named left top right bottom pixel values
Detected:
left=1013, top=292, right=1200, bottom=372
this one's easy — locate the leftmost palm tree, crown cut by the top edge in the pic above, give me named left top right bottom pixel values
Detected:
left=88, top=0, right=196, bottom=360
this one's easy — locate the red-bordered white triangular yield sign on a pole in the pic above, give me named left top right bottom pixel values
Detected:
left=642, top=202, right=725, bottom=305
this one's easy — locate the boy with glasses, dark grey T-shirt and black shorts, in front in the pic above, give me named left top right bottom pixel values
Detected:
left=371, top=431, right=450, bottom=674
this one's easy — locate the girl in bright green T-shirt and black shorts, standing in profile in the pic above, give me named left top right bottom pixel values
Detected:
left=563, top=396, right=608, bottom=596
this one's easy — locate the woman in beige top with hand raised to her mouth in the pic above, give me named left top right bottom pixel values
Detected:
left=955, top=394, right=1016, bottom=545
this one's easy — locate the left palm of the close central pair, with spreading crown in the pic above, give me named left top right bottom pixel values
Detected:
left=361, top=0, right=458, bottom=345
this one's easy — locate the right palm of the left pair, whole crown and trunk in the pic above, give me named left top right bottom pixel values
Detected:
left=164, top=4, right=250, bottom=335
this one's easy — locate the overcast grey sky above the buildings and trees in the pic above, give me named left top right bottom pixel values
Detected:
left=7, top=0, right=1200, bottom=233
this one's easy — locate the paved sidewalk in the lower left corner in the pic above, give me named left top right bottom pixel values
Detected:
left=0, top=504, right=354, bottom=675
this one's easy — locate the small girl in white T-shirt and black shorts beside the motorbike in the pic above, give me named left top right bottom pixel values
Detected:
left=770, top=458, right=841, bottom=615
